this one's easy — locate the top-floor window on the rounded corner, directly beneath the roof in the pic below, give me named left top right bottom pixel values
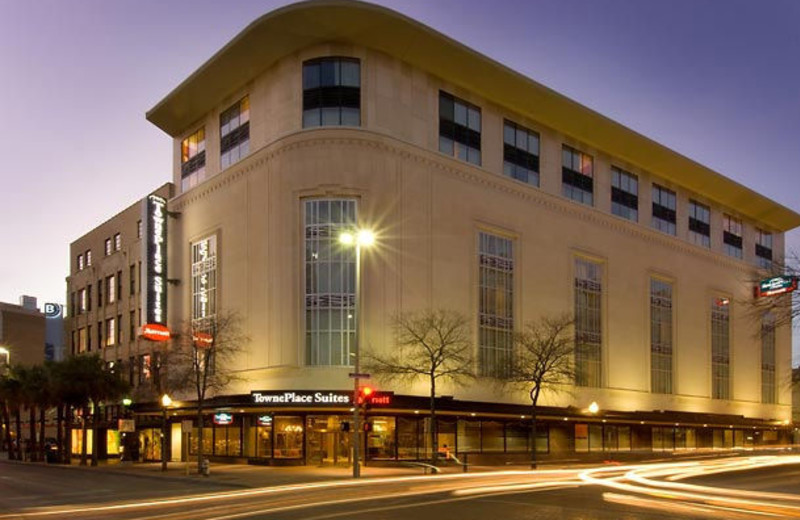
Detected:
left=303, top=58, right=361, bottom=128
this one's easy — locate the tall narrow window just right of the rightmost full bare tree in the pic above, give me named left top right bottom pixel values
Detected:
left=575, top=258, right=603, bottom=387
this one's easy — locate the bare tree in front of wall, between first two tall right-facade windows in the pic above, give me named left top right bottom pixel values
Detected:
left=508, top=314, right=575, bottom=469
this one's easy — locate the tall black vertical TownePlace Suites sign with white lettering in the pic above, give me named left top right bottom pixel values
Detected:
left=142, top=195, right=167, bottom=325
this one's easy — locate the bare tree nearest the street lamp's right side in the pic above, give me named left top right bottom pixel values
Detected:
left=364, top=309, right=474, bottom=464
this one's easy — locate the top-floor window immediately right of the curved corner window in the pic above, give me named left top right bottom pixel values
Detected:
left=439, top=91, right=481, bottom=166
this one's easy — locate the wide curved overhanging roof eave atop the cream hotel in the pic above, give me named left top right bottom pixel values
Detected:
left=147, top=0, right=800, bottom=231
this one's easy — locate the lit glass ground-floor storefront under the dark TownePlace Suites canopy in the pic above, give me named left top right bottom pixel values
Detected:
left=122, top=391, right=791, bottom=465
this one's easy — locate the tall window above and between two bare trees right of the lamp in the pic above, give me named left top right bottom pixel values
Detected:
left=478, top=232, right=514, bottom=377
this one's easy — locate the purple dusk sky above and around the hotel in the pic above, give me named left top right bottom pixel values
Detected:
left=0, top=0, right=800, bottom=358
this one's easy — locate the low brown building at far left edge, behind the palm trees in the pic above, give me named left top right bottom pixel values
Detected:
left=0, top=296, right=45, bottom=371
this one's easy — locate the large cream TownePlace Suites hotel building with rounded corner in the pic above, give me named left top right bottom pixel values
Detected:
left=70, top=1, right=800, bottom=463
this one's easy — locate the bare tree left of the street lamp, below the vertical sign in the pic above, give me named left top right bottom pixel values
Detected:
left=166, top=312, right=249, bottom=473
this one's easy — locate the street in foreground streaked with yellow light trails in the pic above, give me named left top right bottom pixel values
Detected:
left=0, top=456, right=800, bottom=520
